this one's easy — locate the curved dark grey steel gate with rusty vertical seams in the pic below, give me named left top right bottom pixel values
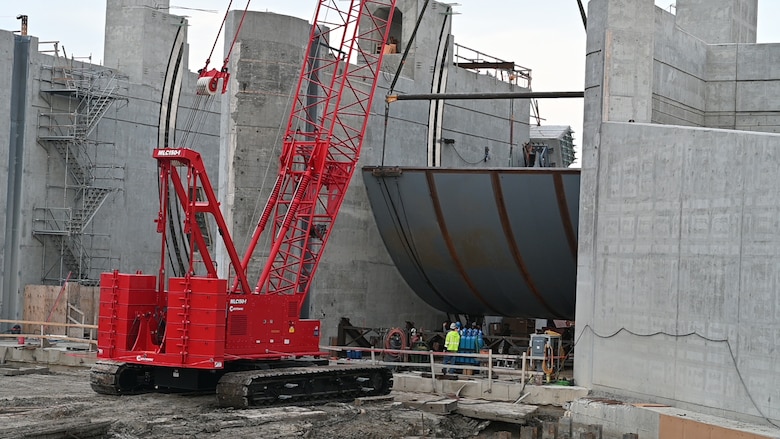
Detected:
left=363, top=167, right=580, bottom=320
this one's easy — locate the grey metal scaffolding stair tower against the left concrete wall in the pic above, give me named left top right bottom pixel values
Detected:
left=33, top=57, right=127, bottom=285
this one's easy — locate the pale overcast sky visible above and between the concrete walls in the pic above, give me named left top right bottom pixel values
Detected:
left=0, top=0, right=780, bottom=165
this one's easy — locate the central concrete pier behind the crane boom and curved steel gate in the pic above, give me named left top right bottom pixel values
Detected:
left=220, top=0, right=529, bottom=341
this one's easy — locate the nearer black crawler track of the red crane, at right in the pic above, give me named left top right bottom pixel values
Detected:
left=217, top=365, right=393, bottom=408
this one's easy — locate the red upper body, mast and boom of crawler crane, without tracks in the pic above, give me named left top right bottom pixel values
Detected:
left=98, top=0, right=396, bottom=369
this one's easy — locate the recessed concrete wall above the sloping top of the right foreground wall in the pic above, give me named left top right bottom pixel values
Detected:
left=652, top=0, right=780, bottom=132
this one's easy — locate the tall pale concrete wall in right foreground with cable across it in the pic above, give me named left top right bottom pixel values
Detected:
left=575, top=0, right=780, bottom=430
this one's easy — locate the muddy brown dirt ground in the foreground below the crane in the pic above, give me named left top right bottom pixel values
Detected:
left=0, top=368, right=560, bottom=439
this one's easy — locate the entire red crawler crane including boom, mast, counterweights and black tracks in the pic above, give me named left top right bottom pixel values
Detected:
left=91, top=0, right=396, bottom=407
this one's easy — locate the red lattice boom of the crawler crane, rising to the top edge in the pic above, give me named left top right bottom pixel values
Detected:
left=242, top=0, right=395, bottom=303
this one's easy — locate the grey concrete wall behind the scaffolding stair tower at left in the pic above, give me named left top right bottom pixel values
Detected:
left=0, top=0, right=219, bottom=329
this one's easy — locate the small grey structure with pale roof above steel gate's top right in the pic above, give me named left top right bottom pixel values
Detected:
left=525, top=125, right=574, bottom=168
